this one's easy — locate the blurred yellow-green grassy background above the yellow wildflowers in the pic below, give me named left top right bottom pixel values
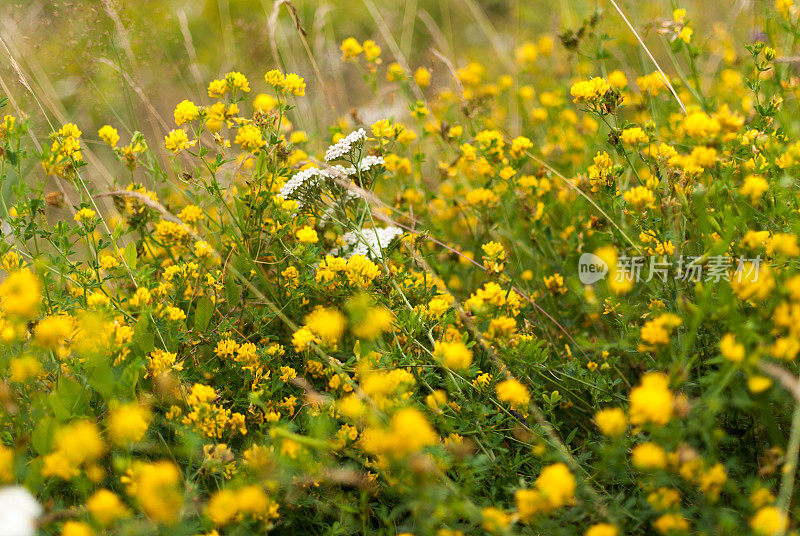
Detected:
left=0, top=0, right=759, bottom=140
